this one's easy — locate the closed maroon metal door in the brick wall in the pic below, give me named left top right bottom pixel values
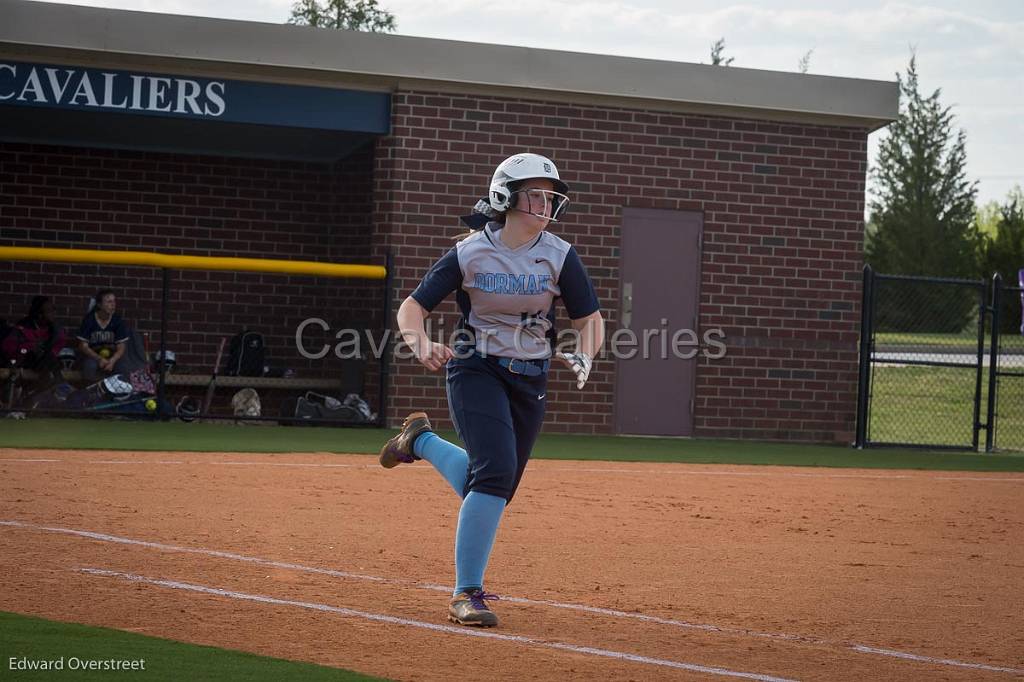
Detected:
left=615, top=208, right=703, bottom=436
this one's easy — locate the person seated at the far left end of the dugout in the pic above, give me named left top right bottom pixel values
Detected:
left=2, top=296, right=66, bottom=393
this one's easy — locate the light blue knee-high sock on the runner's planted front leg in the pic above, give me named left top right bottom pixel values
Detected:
left=453, top=491, right=505, bottom=596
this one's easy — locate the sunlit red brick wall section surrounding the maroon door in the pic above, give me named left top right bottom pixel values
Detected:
left=374, top=92, right=867, bottom=441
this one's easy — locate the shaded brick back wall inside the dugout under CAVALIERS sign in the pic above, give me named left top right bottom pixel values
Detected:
left=0, top=143, right=382, bottom=399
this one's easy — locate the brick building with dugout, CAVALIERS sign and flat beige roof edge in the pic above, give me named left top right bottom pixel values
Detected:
left=0, top=0, right=897, bottom=442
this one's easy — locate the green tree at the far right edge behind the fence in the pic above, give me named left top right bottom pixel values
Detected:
left=984, top=185, right=1024, bottom=333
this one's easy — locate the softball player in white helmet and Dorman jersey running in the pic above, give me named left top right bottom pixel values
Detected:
left=380, top=154, right=604, bottom=627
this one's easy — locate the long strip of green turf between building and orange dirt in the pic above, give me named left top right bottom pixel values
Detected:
left=0, top=419, right=1024, bottom=471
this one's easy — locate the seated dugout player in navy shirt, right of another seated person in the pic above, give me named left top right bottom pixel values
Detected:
left=78, top=289, right=145, bottom=382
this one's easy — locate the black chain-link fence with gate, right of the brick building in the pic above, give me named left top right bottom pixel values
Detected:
left=856, top=266, right=1024, bottom=452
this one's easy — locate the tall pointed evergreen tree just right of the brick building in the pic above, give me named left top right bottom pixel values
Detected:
left=865, top=55, right=983, bottom=332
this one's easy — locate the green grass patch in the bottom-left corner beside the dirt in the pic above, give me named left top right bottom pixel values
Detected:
left=0, top=611, right=381, bottom=682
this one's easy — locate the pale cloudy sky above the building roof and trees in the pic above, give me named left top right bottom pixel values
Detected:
left=32, top=0, right=1024, bottom=203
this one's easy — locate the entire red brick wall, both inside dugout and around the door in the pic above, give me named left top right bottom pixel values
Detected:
left=0, top=92, right=867, bottom=441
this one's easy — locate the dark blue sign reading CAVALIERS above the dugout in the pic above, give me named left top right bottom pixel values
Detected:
left=0, top=61, right=391, bottom=134
